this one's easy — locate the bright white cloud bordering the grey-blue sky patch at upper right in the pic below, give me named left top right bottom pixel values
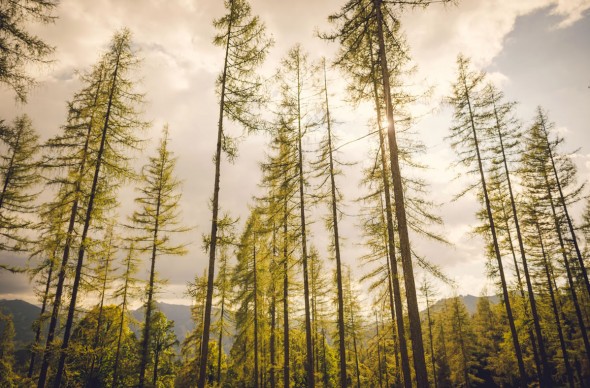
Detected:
left=402, top=0, right=590, bottom=99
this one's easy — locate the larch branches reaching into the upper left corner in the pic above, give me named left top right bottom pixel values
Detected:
left=0, top=0, right=58, bottom=102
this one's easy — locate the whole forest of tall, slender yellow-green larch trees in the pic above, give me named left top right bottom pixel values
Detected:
left=0, top=0, right=590, bottom=388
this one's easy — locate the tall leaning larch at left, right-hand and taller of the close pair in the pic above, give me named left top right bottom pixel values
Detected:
left=39, top=30, right=146, bottom=387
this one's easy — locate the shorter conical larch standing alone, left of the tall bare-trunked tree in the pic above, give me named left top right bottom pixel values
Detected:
left=131, top=127, right=188, bottom=387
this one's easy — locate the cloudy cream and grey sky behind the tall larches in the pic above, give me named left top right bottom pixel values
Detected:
left=0, top=0, right=590, bottom=304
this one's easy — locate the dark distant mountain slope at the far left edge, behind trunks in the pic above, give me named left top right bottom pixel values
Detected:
left=0, top=299, right=41, bottom=349
